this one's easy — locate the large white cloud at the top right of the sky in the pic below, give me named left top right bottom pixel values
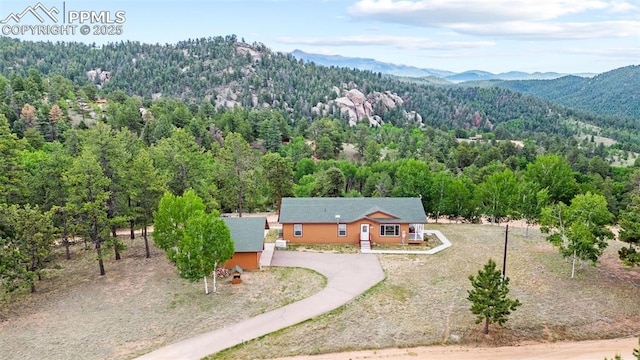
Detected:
left=348, top=0, right=640, bottom=40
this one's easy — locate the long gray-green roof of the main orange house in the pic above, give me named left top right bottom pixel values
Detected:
left=279, top=198, right=427, bottom=224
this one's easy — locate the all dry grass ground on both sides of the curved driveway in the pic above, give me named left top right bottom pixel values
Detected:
left=0, top=224, right=640, bottom=359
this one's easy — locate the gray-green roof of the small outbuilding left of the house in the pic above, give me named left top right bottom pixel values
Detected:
left=222, top=217, right=268, bottom=252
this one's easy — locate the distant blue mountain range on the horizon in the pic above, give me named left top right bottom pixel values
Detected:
left=291, top=49, right=595, bottom=83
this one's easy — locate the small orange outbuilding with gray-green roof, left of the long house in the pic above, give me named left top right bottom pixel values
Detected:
left=222, top=217, right=269, bottom=270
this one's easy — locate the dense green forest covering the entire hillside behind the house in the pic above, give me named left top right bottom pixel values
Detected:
left=0, top=37, right=640, bottom=291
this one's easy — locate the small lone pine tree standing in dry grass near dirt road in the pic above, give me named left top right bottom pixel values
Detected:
left=467, top=259, right=522, bottom=334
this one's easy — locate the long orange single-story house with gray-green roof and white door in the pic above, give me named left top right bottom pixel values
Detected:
left=278, top=198, right=427, bottom=246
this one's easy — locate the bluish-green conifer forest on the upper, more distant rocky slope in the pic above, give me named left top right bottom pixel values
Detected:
left=0, top=35, right=640, bottom=152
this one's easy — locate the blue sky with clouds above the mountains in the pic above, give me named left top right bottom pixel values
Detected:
left=0, top=0, right=640, bottom=73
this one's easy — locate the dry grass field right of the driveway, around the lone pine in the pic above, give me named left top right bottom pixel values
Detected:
left=210, top=224, right=640, bottom=359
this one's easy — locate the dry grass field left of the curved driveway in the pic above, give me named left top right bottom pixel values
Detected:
left=0, top=235, right=325, bottom=360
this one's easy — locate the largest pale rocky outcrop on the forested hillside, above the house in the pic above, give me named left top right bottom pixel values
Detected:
left=311, top=87, right=422, bottom=126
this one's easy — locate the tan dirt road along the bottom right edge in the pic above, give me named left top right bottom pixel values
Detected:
left=274, top=337, right=638, bottom=360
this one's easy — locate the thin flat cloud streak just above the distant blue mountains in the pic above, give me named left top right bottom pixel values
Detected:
left=275, top=35, right=495, bottom=50
